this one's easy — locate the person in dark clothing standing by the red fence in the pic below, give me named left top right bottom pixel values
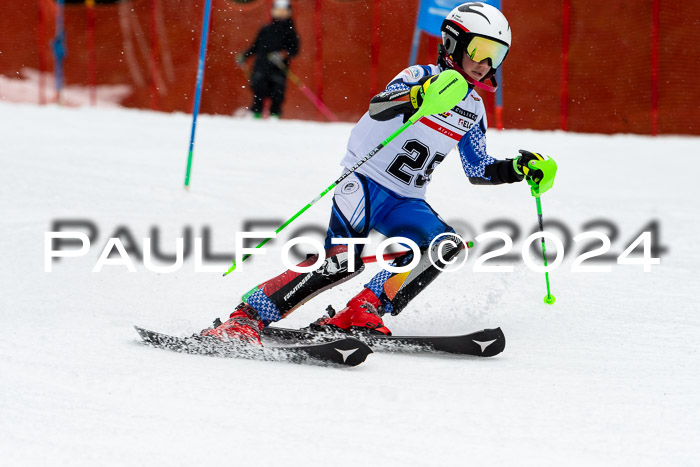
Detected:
left=237, top=0, right=299, bottom=118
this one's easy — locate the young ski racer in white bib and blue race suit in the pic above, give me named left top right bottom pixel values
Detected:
left=202, top=2, right=556, bottom=343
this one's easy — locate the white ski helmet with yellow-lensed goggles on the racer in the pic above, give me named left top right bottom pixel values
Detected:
left=440, top=2, right=510, bottom=74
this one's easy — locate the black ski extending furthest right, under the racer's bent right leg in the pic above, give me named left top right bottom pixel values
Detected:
left=262, top=326, right=506, bottom=357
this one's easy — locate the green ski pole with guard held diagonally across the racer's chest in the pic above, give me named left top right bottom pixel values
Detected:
left=224, top=70, right=469, bottom=276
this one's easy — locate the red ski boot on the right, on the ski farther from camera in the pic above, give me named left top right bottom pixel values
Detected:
left=312, top=288, right=391, bottom=336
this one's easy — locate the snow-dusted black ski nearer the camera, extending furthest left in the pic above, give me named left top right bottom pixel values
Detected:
left=134, top=326, right=372, bottom=366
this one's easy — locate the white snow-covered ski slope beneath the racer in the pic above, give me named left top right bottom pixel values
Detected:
left=0, top=103, right=700, bottom=466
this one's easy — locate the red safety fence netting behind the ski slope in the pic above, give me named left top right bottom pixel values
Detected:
left=0, top=0, right=700, bottom=135
